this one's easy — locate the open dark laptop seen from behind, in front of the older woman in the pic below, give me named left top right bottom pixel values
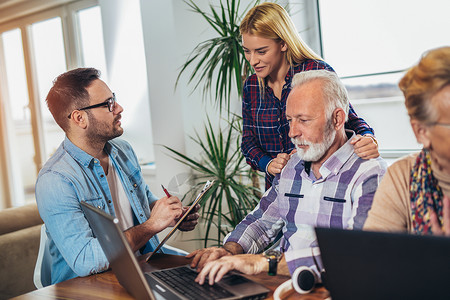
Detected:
left=316, top=228, right=450, bottom=300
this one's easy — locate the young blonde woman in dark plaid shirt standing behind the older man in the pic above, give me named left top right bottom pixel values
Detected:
left=240, top=3, right=379, bottom=189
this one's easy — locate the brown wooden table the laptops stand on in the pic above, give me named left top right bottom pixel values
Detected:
left=14, top=254, right=329, bottom=300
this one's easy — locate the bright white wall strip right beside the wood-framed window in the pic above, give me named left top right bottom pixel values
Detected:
left=99, top=0, right=154, bottom=162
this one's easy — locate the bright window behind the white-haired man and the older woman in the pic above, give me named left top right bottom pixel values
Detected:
left=318, top=0, right=450, bottom=155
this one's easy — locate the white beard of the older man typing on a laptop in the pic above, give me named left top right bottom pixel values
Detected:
left=291, top=124, right=336, bottom=162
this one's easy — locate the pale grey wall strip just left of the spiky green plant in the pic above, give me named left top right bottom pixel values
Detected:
left=141, top=1, right=195, bottom=192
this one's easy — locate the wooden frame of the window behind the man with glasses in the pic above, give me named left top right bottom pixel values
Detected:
left=0, top=0, right=99, bottom=208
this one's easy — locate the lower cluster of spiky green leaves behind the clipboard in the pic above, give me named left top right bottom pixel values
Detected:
left=165, top=117, right=259, bottom=247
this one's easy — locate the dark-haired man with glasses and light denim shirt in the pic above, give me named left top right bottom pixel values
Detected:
left=36, top=68, right=198, bottom=284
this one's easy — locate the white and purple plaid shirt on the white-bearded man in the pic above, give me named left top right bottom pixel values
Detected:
left=226, top=131, right=387, bottom=273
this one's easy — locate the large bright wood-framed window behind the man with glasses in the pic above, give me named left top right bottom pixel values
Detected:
left=0, top=0, right=106, bottom=208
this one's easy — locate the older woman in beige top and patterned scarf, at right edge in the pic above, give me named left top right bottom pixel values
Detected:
left=364, top=47, right=450, bottom=235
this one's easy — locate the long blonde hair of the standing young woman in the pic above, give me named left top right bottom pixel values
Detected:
left=239, top=2, right=323, bottom=93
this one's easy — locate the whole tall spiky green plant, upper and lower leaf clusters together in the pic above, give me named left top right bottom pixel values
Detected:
left=165, top=0, right=261, bottom=247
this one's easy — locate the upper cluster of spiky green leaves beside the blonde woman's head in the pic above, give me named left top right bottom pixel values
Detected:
left=176, top=0, right=260, bottom=112
